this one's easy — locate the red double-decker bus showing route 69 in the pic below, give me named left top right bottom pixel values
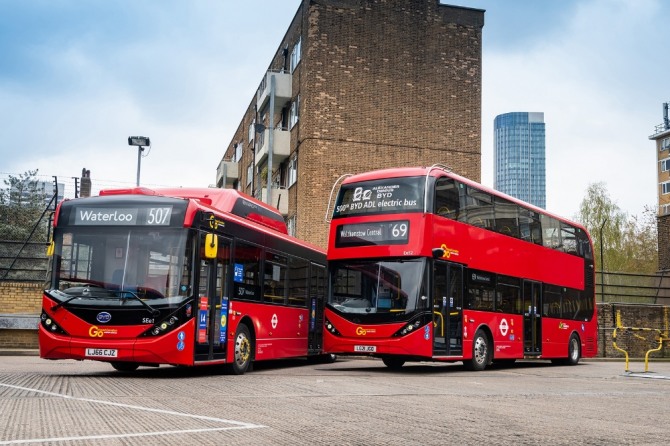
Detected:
left=324, top=166, right=597, bottom=370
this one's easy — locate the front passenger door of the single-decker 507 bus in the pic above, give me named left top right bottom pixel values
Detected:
left=195, top=236, right=230, bottom=361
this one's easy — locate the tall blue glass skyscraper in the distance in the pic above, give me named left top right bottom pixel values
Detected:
left=493, top=112, right=547, bottom=209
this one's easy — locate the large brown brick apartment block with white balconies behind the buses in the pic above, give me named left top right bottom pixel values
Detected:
left=216, top=0, right=484, bottom=247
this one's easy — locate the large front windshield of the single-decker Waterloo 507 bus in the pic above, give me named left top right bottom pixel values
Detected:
left=53, top=226, right=189, bottom=304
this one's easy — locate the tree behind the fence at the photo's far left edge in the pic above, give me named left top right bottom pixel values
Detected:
left=0, top=170, right=49, bottom=241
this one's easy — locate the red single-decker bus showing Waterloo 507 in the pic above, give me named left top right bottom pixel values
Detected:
left=39, top=188, right=327, bottom=374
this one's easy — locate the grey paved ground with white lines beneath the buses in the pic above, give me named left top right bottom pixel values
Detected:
left=0, top=355, right=670, bottom=446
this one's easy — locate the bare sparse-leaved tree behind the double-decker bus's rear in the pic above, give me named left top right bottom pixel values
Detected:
left=577, top=183, right=658, bottom=274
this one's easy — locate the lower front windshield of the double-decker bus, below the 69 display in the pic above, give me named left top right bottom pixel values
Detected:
left=329, top=259, right=428, bottom=319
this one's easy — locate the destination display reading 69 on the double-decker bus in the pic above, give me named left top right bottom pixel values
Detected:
left=335, top=220, right=409, bottom=248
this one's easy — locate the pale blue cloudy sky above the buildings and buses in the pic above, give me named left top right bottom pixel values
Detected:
left=0, top=0, right=670, bottom=218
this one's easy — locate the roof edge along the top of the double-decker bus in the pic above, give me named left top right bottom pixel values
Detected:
left=342, top=166, right=586, bottom=230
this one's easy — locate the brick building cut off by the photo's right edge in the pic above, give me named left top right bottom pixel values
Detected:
left=649, top=102, right=670, bottom=273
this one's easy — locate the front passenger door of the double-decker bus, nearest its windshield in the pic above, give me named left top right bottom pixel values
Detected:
left=433, top=260, right=463, bottom=356
